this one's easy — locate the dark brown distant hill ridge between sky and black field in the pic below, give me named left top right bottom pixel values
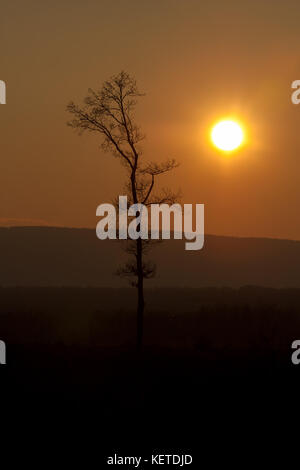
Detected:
left=0, top=227, right=300, bottom=287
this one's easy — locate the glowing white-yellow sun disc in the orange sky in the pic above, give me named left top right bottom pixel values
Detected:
left=211, top=120, right=244, bottom=152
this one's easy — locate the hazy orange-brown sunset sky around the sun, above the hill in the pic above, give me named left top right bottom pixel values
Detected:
left=0, top=0, right=300, bottom=239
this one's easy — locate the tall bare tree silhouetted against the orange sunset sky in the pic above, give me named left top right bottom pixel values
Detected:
left=67, top=71, right=178, bottom=351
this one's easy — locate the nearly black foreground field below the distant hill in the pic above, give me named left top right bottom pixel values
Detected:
left=0, top=287, right=300, bottom=458
